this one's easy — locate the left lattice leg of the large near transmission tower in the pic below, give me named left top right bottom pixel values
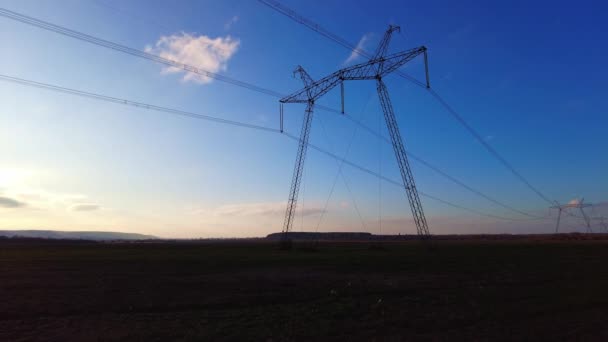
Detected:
left=282, top=102, right=314, bottom=242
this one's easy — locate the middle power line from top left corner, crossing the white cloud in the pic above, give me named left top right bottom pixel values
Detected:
left=0, top=9, right=534, bottom=222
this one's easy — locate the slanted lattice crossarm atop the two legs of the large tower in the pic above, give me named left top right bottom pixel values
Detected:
left=280, top=46, right=426, bottom=103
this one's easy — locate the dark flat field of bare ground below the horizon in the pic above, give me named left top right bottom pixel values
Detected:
left=0, top=240, right=608, bottom=341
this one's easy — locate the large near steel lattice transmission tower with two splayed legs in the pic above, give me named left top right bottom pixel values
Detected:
left=280, top=25, right=430, bottom=237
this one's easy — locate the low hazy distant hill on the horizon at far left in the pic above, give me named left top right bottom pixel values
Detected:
left=0, top=230, right=158, bottom=241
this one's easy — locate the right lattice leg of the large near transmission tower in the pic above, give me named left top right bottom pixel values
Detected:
left=377, top=79, right=430, bottom=237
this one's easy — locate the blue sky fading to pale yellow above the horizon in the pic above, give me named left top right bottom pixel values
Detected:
left=0, top=0, right=608, bottom=237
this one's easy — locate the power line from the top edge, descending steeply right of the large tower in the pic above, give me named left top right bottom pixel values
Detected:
left=258, top=0, right=553, bottom=206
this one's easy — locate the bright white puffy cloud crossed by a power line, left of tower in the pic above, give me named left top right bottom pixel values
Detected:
left=146, top=32, right=240, bottom=84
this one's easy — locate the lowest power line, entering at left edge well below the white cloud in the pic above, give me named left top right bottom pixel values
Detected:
left=0, top=74, right=548, bottom=221
